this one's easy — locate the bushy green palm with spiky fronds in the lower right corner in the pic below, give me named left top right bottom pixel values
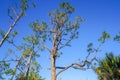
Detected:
left=95, top=53, right=120, bottom=80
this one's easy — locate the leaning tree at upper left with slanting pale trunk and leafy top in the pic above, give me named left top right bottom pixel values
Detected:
left=0, top=0, right=35, bottom=47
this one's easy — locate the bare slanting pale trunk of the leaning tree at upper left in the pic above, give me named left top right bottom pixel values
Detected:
left=0, top=11, right=23, bottom=47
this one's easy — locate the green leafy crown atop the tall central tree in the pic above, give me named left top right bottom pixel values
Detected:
left=46, top=2, right=84, bottom=53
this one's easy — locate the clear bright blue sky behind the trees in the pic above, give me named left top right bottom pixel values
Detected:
left=0, top=0, right=120, bottom=80
